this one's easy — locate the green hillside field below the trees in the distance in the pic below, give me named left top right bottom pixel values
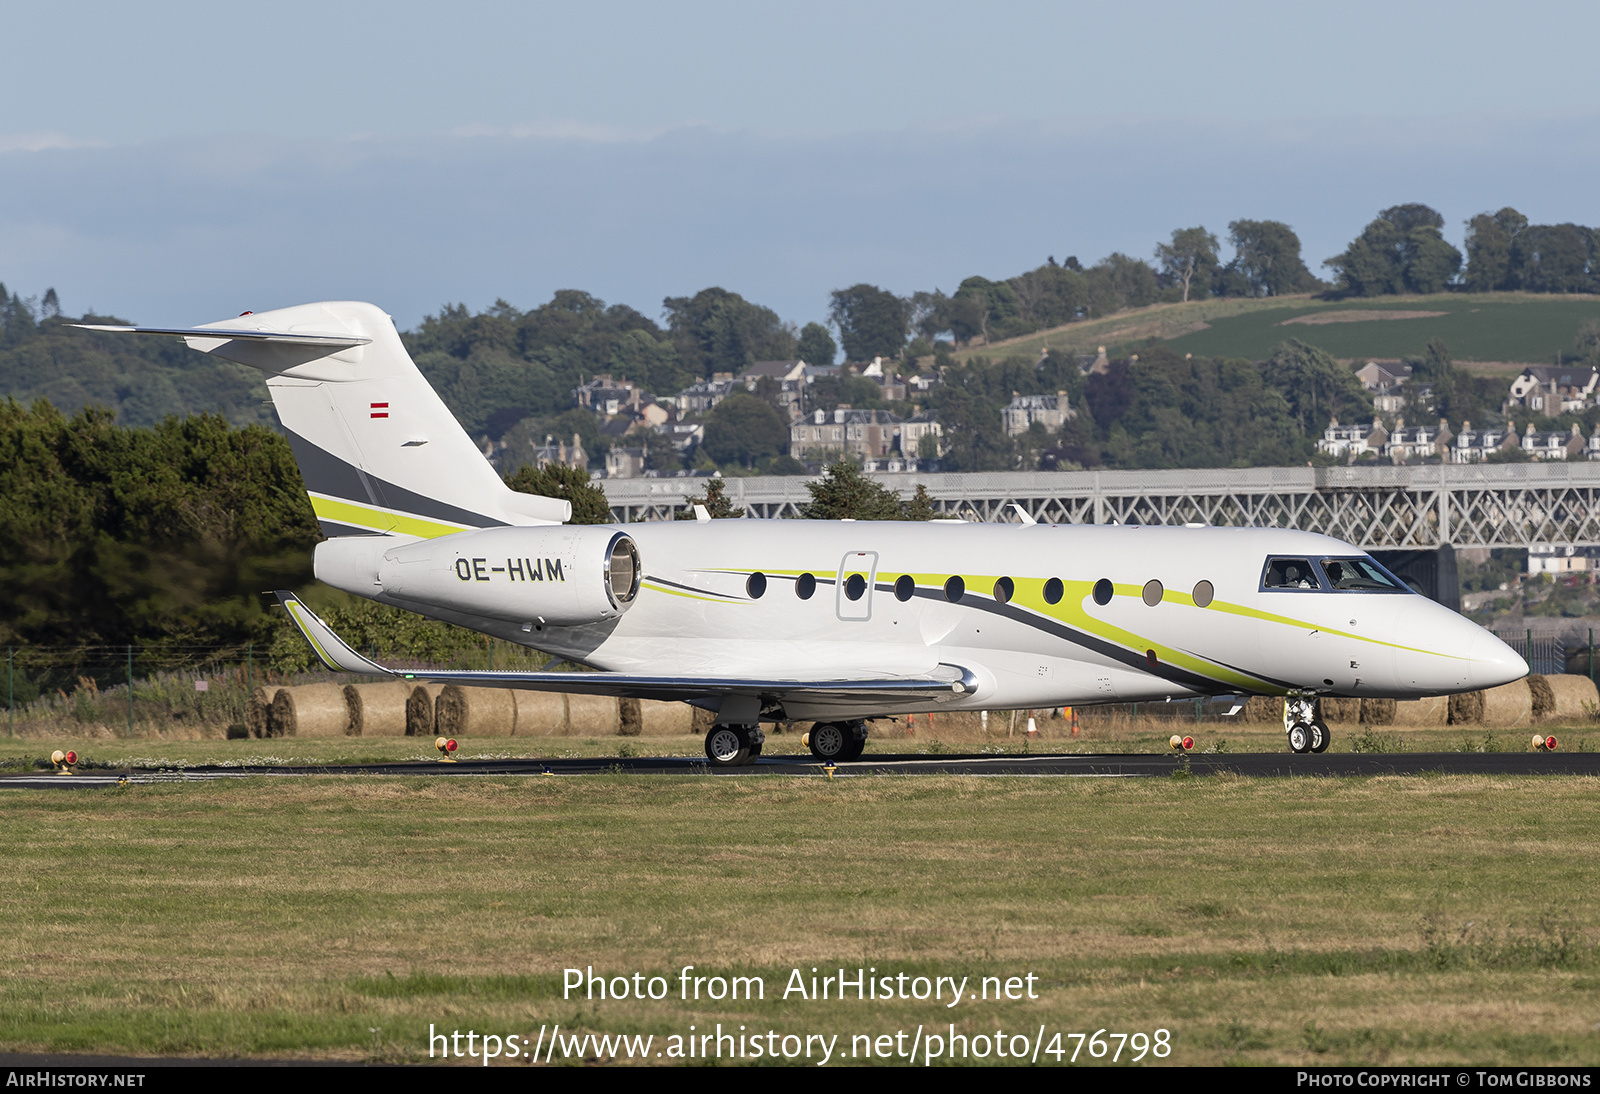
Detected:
left=957, top=293, right=1600, bottom=365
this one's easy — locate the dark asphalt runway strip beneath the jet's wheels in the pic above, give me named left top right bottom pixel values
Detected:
left=0, top=752, right=1600, bottom=790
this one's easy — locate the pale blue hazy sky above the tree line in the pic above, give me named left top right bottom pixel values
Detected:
left=0, top=0, right=1600, bottom=328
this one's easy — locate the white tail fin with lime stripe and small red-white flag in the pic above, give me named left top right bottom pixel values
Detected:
left=81, top=301, right=573, bottom=539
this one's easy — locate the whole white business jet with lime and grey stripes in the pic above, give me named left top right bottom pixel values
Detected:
left=90, top=302, right=1528, bottom=766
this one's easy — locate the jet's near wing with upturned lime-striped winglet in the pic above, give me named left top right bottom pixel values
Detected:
left=277, top=590, right=978, bottom=705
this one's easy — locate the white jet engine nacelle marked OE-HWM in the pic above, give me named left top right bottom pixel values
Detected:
left=308, top=525, right=640, bottom=627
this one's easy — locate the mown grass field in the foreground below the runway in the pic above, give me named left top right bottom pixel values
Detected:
left=0, top=776, right=1600, bottom=1065
